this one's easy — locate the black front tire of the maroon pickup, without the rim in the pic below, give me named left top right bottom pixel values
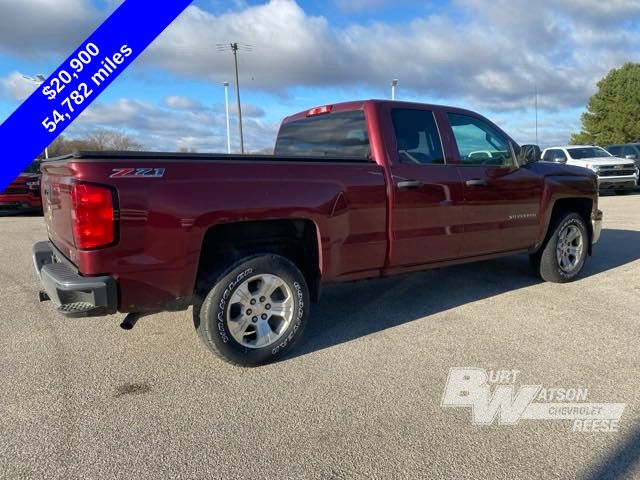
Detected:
left=529, top=213, right=591, bottom=283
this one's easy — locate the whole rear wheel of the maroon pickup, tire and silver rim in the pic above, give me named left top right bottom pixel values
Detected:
left=193, top=254, right=310, bottom=367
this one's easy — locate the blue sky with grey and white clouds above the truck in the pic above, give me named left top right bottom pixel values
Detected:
left=0, top=0, right=640, bottom=152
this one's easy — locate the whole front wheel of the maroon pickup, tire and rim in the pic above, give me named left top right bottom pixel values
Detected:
left=530, top=213, right=589, bottom=283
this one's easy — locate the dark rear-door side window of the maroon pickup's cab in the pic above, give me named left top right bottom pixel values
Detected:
left=391, top=109, right=444, bottom=165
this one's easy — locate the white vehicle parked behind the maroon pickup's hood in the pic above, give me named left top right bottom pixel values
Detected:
left=542, top=145, right=638, bottom=194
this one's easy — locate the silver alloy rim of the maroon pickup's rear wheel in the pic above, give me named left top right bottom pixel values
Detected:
left=227, top=273, right=295, bottom=348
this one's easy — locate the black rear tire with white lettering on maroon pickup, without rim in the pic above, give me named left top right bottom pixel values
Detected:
left=193, top=254, right=311, bottom=367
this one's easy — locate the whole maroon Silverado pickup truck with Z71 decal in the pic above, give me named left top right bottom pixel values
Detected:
left=33, top=100, right=602, bottom=366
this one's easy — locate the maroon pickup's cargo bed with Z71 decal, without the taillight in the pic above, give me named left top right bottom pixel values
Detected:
left=42, top=152, right=387, bottom=311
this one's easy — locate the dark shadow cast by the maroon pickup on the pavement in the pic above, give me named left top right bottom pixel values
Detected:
left=287, top=229, right=640, bottom=359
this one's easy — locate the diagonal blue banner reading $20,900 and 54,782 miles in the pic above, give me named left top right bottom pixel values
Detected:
left=0, top=0, right=192, bottom=191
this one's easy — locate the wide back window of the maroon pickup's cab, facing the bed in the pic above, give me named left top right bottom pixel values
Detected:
left=274, top=110, right=371, bottom=159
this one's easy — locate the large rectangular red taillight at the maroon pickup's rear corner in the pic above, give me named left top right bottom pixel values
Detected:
left=71, top=183, right=115, bottom=249
